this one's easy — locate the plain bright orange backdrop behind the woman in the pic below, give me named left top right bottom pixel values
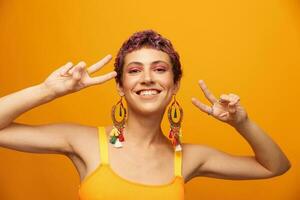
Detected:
left=0, top=0, right=300, bottom=200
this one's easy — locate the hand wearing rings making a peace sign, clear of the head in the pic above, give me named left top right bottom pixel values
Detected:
left=192, top=80, right=248, bottom=127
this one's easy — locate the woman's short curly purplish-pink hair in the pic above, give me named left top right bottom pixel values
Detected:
left=114, top=30, right=182, bottom=86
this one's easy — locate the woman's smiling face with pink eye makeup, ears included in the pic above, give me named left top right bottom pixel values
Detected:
left=117, top=48, right=179, bottom=114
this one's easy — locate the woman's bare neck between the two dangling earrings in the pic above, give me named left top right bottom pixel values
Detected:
left=125, top=110, right=166, bottom=149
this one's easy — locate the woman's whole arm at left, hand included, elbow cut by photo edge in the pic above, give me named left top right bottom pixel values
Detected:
left=0, top=56, right=116, bottom=154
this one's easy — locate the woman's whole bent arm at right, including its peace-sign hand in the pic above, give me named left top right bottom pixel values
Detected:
left=191, top=81, right=291, bottom=179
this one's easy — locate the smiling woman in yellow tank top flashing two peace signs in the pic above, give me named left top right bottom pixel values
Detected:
left=0, top=30, right=291, bottom=200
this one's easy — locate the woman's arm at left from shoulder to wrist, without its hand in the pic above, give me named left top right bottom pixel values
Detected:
left=0, top=84, right=72, bottom=153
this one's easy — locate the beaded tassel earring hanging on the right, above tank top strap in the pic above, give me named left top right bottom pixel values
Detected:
left=168, top=95, right=183, bottom=151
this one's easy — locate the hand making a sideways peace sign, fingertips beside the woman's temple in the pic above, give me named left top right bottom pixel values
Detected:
left=43, top=55, right=117, bottom=97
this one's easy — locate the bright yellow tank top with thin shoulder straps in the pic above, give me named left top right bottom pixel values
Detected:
left=78, top=127, right=184, bottom=200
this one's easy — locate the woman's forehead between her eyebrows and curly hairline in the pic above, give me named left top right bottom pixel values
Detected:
left=124, top=48, right=171, bottom=66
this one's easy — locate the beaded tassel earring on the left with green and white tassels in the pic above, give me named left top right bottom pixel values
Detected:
left=109, top=96, right=127, bottom=148
